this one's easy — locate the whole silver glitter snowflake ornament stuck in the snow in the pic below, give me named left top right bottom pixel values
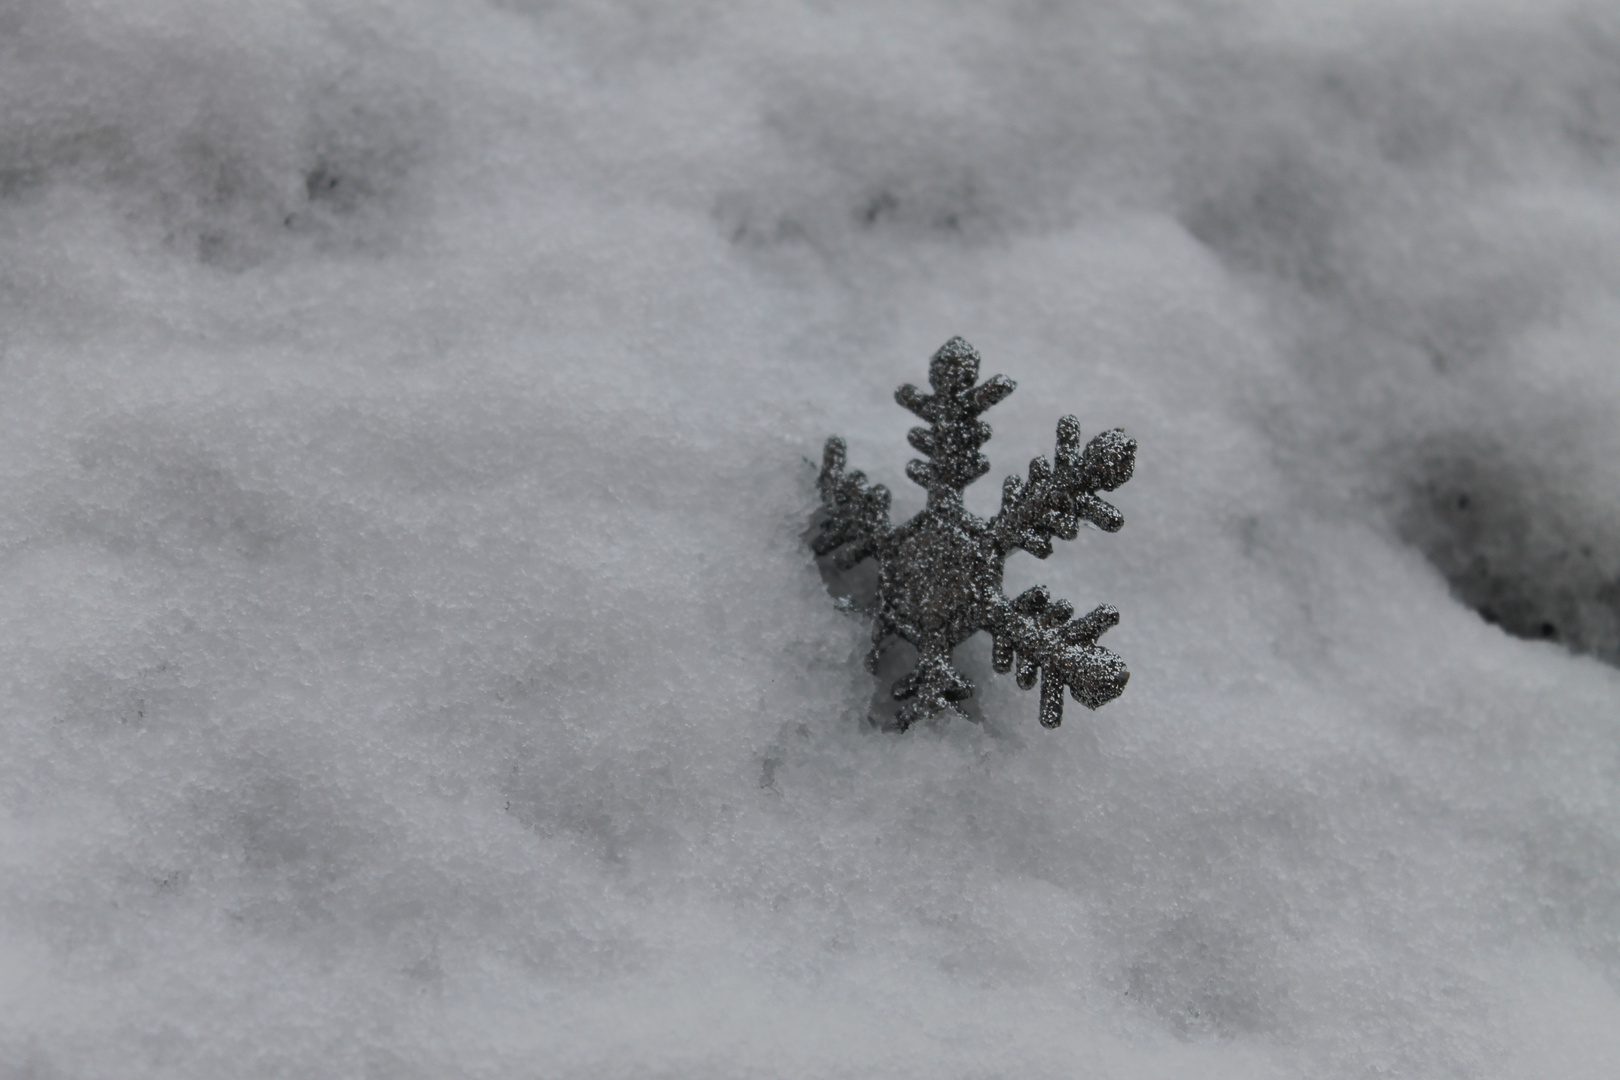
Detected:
left=812, top=337, right=1136, bottom=730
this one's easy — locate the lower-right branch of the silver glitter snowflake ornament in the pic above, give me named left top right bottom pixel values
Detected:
left=991, top=586, right=1131, bottom=727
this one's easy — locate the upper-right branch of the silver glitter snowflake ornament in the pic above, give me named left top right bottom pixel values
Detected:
left=990, top=416, right=1136, bottom=559
